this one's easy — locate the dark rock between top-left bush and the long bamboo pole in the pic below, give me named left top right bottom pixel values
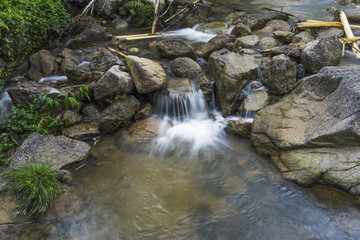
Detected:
left=68, top=26, right=107, bottom=49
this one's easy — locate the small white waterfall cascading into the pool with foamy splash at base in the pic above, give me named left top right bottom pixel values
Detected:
left=153, top=88, right=226, bottom=157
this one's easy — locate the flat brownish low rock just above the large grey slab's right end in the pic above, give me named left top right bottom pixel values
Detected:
left=63, top=122, right=100, bottom=140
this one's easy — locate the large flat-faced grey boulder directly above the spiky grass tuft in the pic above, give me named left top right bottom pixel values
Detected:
left=10, top=133, right=90, bottom=170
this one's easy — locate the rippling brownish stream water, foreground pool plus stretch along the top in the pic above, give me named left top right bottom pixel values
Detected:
left=4, top=0, right=360, bottom=240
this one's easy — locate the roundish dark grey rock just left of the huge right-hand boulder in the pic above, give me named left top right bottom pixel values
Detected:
left=261, top=59, right=297, bottom=95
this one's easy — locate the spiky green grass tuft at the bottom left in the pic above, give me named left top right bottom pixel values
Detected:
left=4, top=163, right=61, bottom=216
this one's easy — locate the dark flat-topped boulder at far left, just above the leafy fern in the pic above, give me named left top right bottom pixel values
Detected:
left=8, top=82, right=63, bottom=106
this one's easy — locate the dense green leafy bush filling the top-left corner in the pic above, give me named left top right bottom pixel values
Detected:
left=0, top=0, right=70, bottom=79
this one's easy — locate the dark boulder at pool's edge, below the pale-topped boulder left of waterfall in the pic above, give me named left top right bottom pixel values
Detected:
left=99, top=95, right=140, bottom=133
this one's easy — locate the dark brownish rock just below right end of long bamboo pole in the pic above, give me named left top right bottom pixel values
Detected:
left=156, top=39, right=197, bottom=60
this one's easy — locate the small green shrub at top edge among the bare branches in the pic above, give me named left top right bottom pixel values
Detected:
left=129, top=0, right=154, bottom=26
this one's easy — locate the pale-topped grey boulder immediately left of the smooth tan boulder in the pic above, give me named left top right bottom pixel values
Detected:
left=94, top=65, right=134, bottom=101
